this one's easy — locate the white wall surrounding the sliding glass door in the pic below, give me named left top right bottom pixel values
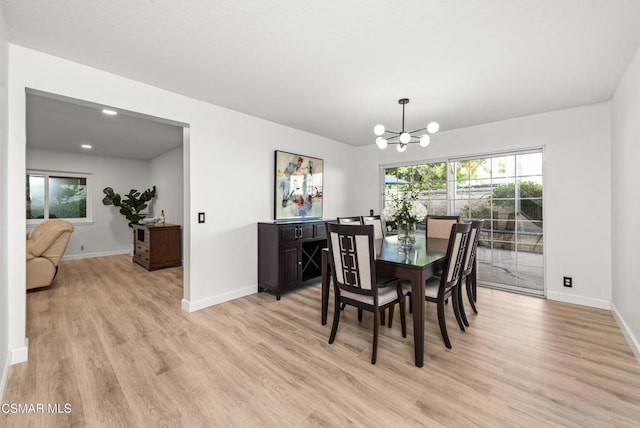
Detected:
left=354, top=103, right=611, bottom=308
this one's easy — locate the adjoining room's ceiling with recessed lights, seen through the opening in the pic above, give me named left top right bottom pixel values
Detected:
left=26, top=90, right=183, bottom=160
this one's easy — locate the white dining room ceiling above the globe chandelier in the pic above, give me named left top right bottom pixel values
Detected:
left=7, top=0, right=640, bottom=146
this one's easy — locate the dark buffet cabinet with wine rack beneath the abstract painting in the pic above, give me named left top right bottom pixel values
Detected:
left=258, top=220, right=327, bottom=300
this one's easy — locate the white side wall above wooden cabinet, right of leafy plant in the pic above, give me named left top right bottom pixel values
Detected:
left=149, top=146, right=184, bottom=225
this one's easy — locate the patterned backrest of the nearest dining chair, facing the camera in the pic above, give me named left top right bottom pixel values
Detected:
left=327, top=223, right=377, bottom=295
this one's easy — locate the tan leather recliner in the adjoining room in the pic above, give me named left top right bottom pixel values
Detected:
left=27, top=220, right=73, bottom=290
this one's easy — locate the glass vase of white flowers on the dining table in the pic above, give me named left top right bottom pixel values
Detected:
left=382, top=192, right=427, bottom=250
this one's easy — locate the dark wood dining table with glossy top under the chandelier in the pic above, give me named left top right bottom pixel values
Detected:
left=321, top=235, right=449, bottom=367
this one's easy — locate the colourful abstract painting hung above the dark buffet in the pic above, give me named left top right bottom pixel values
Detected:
left=273, top=150, right=324, bottom=221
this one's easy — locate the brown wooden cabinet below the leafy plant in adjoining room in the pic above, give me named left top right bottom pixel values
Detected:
left=133, top=224, right=182, bottom=270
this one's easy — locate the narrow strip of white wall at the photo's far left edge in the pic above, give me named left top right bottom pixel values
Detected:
left=0, top=7, right=10, bottom=396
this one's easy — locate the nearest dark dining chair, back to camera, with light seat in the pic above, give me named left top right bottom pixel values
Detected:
left=326, top=223, right=407, bottom=364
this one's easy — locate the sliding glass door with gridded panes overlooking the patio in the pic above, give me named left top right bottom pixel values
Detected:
left=383, top=150, right=544, bottom=295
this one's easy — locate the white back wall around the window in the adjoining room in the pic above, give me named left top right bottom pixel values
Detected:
left=26, top=149, right=150, bottom=260
